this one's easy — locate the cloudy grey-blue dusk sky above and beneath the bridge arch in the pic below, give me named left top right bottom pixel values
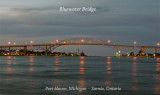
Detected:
left=0, top=0, right=160, bottom=55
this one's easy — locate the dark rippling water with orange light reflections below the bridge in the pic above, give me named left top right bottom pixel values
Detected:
left=0, top=56, right=160, bottom=95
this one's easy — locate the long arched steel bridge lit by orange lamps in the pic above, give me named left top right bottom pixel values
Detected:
left=0, top=38, right=160, bottom=55
